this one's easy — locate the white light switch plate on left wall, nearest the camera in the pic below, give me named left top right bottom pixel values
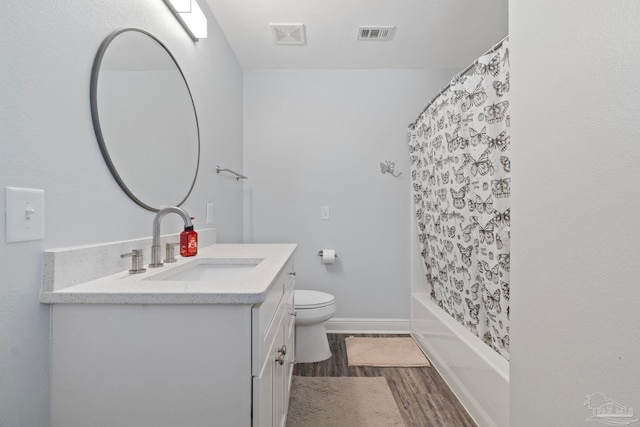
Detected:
left=5, top=187, right=44, bottom=243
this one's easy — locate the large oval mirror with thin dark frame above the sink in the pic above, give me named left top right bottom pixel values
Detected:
left=91, top=28, right=200, bottom=211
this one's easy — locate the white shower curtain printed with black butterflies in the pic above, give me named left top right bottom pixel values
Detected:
left=409, top=40, right=511, bottom=360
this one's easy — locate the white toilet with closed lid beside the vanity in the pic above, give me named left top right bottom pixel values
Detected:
left=294, top=290, right=336, bottom=363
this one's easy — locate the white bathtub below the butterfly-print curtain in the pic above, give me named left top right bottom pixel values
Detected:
left=411, top=288, right=509, bottom=427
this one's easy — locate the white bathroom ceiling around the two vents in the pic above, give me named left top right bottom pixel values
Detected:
left=205, top=0, right=508, bottom=69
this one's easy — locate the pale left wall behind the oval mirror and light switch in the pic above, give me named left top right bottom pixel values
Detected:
left=0, top=0, right=242, bottom=427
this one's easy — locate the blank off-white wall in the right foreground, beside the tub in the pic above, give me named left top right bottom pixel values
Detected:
left=509, top=0, right=640, bottom=427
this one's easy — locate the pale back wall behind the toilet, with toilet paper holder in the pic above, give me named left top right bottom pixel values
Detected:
left=244, top=70, right=453, bottom=319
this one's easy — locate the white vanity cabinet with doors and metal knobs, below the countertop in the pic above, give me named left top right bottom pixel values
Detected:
left=50, top=250, right=295, bottom=427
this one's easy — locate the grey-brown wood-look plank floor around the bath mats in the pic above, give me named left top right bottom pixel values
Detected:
left=293, top=334, right=476, bottom=427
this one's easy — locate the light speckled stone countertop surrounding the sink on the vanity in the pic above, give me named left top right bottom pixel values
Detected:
left=40, top=244, right=296, bottom=304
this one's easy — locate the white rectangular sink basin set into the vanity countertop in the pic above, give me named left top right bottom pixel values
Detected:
left=148, top=258, right=264, bottom=282
